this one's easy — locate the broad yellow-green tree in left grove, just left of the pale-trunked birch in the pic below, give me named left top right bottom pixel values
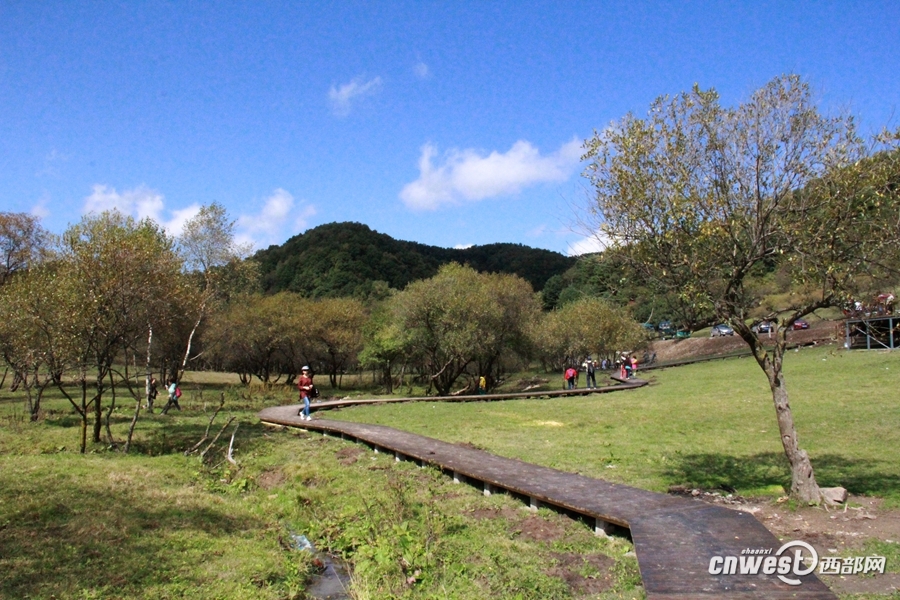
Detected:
left=58, top=211, right=181, bottom=452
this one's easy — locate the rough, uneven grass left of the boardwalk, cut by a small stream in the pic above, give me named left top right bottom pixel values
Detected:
left=0, top=376, right=642, bottom=600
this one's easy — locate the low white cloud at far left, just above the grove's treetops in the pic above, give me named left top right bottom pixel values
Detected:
left=81, top=183, right=200, bottom=235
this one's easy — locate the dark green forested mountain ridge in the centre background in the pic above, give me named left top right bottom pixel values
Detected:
left=254, top=223, right=575, bottom=298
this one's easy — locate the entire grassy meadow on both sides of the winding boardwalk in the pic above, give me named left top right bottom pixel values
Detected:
left=0, top=347, right=900, bottom=600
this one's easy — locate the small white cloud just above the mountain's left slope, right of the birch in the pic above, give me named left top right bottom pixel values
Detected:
left=236, top=188, right=316, bottom=248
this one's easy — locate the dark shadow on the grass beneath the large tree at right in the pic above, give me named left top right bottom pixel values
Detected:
left=664, top=452, right=900, bottom=498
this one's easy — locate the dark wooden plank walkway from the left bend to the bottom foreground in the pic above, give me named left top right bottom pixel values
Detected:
left=259, top=406, right=837, bottom=600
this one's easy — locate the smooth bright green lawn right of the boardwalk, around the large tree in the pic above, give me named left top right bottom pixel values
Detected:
left=333, top=347, right=900, bottom=503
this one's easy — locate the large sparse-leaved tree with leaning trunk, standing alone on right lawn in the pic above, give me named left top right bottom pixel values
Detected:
left=584, top=75, right=900, bottom=502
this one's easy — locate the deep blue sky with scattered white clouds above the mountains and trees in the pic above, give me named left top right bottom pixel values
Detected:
left=0, top=0, right=900, bottom=253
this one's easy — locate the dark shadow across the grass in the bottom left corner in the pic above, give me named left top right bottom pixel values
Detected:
left=0, top=474, right=280, bottom=598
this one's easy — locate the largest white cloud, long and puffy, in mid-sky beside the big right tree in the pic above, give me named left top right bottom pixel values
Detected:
left=400, top=139, right=581, bottom=209
